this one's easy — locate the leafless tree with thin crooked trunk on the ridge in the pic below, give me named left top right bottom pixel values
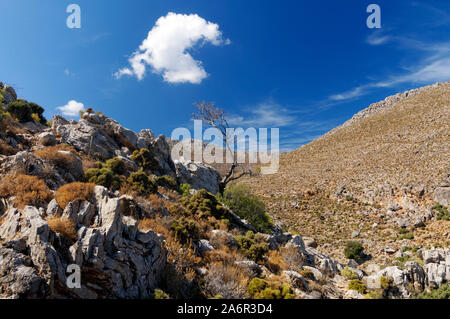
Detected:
left=192, top=102, right=252, bottom=193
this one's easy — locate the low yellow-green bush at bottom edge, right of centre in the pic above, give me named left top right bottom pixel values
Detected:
left=247, top=278, right=295, bottom=299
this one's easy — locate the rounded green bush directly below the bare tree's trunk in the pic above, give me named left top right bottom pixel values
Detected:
left=219, top=184, right=273, bottom=233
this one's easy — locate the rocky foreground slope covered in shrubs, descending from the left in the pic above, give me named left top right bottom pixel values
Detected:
left=0, top=82, right=450, bottom=299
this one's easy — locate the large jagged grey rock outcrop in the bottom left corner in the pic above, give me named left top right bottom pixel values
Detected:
left=0, top=186, right=166, bottom=298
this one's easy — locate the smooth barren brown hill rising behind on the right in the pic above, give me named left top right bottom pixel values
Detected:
left=246, top=82, right=450, bottom=268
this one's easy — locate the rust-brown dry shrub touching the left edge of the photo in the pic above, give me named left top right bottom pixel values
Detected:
left=0, top=174, right=52, bottom=209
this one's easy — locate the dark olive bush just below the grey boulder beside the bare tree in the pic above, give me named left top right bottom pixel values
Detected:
left=182, top=189, right=229, bottom=224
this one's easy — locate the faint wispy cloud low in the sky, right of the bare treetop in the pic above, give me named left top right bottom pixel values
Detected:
left=228, top=102, right=295, bottom=127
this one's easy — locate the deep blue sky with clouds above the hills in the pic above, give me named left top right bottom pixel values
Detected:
left=0, top=0, right=450, bottom=150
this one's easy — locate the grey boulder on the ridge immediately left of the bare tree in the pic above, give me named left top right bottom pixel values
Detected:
left=175, top=160, right=221, bottom=194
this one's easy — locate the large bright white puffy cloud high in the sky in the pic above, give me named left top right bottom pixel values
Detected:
left=114, top=12, right=230, bottom=84
